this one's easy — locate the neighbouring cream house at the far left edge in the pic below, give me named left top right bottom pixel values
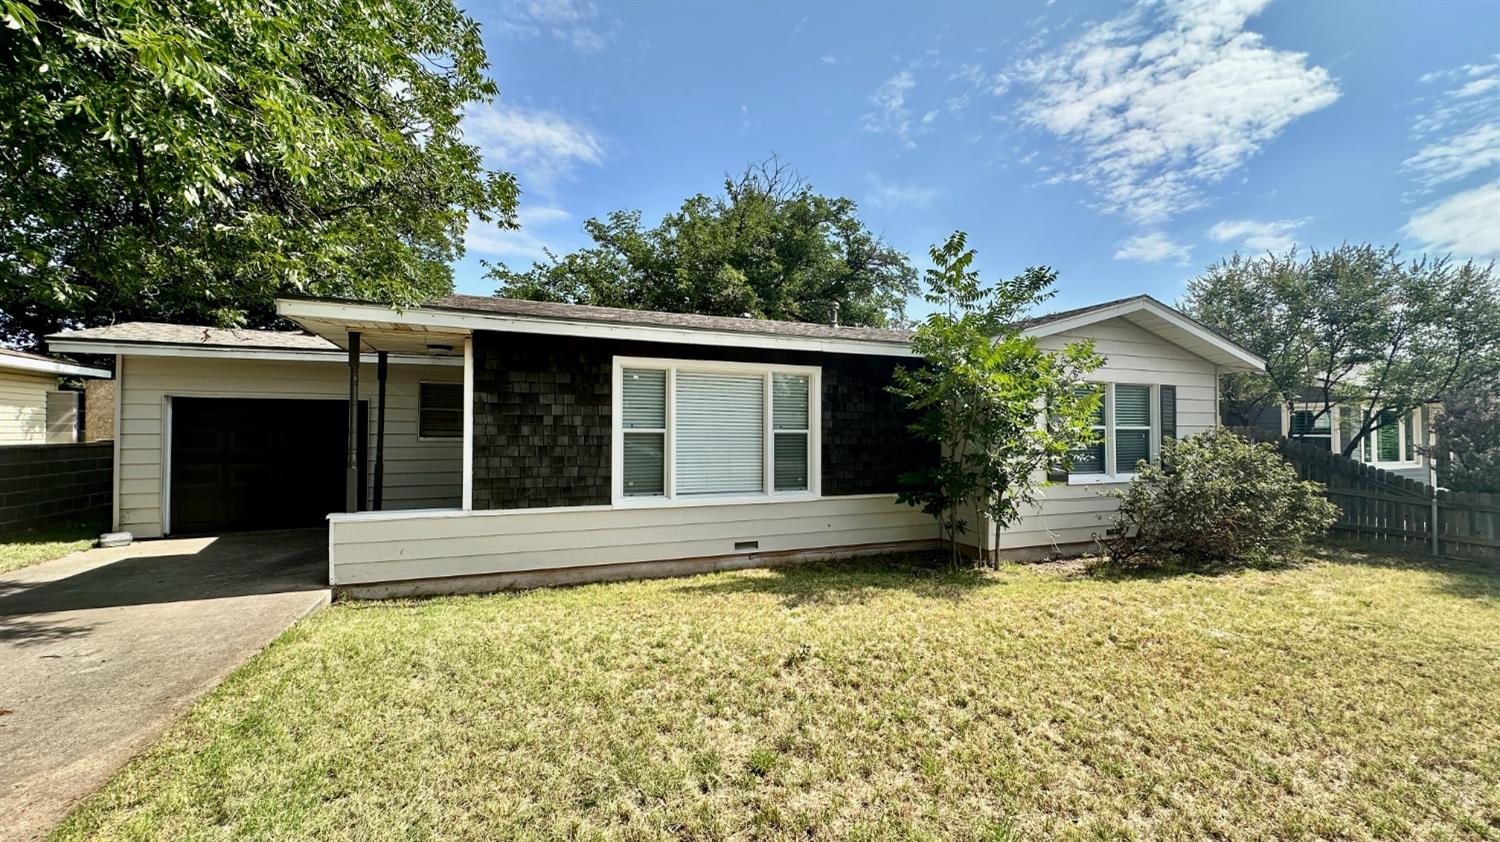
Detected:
left=0, top=348, right=110, bottom=444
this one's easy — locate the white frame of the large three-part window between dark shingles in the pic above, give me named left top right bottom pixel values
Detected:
left=609, top=357, right=822, bottom=509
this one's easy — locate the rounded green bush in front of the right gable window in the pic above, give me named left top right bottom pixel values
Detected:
left=1104, top=429, right=1338, bottom=564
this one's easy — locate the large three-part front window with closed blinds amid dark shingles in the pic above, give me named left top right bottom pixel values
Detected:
left=615, top=359, right=818, bottom=501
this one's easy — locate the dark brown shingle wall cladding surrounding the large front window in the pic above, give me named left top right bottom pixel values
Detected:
left=474, top=332, right=938, bottom=509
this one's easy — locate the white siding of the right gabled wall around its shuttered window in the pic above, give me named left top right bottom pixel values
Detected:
left=990, top=318, right=1218, bottom=557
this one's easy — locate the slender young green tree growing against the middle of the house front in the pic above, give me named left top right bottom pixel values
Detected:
left=891, top=231, right=1103, bottom=563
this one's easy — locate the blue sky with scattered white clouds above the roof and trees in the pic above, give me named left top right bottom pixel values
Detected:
left=456, top=0, right=1500, bottom=312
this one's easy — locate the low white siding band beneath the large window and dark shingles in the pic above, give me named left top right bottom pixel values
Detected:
left=329, top=494, right=938, bottom=585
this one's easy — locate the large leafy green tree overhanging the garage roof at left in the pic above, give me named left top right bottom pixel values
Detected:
left=0, top=0, right=518, bottom=344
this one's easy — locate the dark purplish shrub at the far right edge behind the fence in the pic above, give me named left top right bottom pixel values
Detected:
left=1425, top=381, right=1500, bottom=492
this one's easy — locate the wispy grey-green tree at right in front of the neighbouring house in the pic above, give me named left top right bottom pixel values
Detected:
left=1184, top=245, right=1500, bottom=456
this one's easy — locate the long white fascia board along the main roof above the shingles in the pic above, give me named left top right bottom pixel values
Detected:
left=276, top=299, right=917, bottom=357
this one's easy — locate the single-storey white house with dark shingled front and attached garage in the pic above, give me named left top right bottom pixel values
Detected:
left=50, top=296, right=1263, bottom=596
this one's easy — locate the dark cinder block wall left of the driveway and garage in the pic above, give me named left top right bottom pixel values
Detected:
left=0, top=441, right=114, bottom=533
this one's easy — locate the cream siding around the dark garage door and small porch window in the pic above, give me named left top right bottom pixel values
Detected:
left=116, top=356, right=464, bottom=537
